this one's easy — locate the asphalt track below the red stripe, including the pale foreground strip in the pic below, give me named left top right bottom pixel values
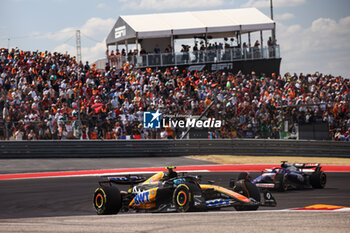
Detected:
left=0, top=157, right=350, bottom=232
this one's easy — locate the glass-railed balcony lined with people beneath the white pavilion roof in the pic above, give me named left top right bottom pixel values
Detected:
left=109, top=41, right=280, bottom=68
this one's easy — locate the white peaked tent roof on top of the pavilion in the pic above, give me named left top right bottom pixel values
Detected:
left=107, top=8, right=275, bottom=44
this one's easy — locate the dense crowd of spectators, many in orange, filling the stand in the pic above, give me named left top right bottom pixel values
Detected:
left=0, top=49, right=350, bottom=141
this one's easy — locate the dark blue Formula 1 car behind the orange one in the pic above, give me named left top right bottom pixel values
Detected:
left=252, top=161, right=327, bottom=192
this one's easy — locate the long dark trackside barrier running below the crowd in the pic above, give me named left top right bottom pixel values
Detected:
left=0, top=139, right=350, bottom=158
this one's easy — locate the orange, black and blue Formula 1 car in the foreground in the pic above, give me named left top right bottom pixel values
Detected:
left=93, top=167, right=276, bottom=215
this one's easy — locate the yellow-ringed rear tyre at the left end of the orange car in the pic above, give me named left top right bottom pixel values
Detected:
left=93, top=186, right=122, bottom=215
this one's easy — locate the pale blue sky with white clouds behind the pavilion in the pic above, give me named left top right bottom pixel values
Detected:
left=0, top=0, right=350, bottom=78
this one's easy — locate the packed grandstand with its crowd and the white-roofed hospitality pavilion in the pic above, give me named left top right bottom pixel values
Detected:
left=0, top=8, right=350, bottom=141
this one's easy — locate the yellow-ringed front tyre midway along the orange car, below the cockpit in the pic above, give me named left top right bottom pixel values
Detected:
left=173, top=184, right=193, bottom=212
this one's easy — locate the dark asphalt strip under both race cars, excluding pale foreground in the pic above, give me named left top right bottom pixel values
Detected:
left=0, top=173, right=350, bottom=219
